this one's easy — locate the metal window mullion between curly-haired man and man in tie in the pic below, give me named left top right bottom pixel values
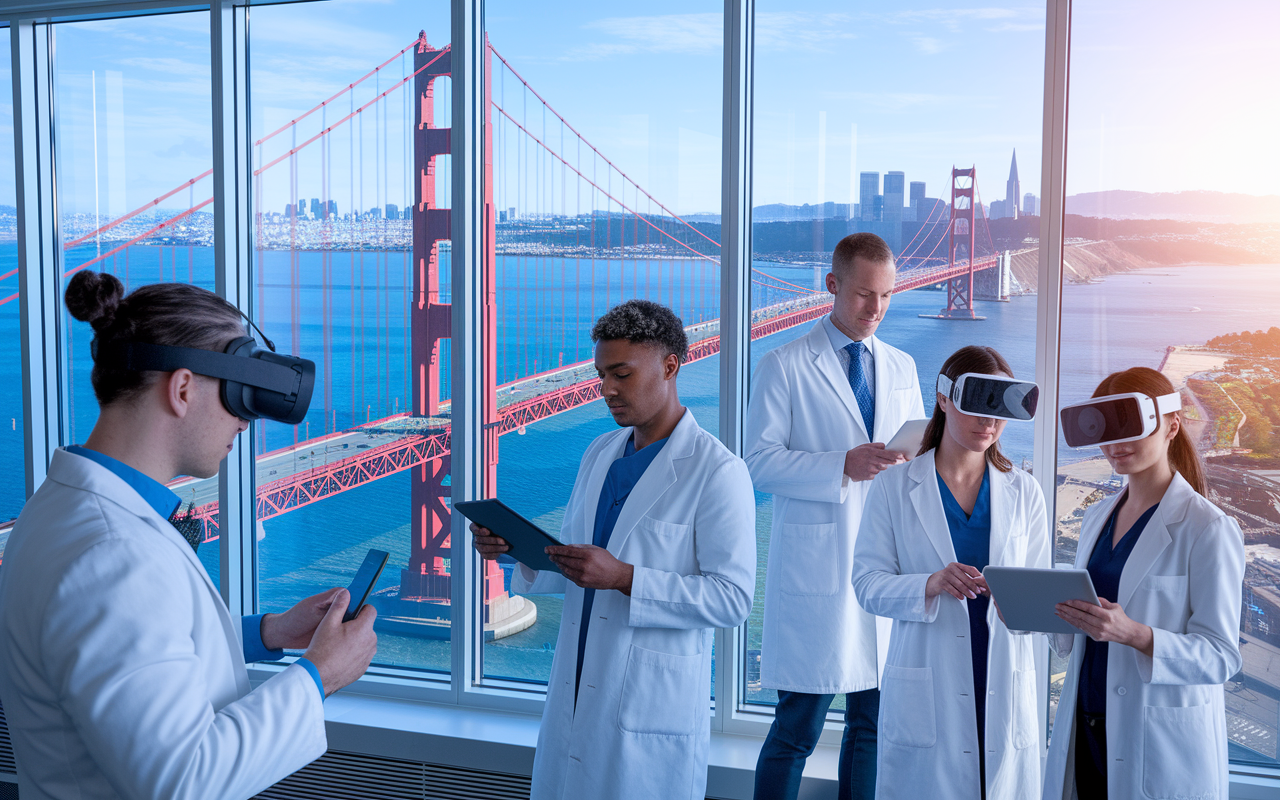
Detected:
left=712, top=0, right=755, bottom=731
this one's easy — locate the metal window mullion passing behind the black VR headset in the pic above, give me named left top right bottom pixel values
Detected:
left=209, top=0, right=257, bottom=614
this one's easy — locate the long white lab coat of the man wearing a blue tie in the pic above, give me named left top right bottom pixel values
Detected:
left=745, top=320, right=924, bottom=694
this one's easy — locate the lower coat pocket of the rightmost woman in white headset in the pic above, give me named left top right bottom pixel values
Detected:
left=1142, top=703, right=1225, bottom=800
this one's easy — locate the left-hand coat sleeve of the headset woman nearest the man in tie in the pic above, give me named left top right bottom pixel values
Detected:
left=852, top=477, right=938, bottom=622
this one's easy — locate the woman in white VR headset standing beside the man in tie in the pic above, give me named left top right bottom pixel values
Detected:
left=852, top=347, right=1050, bottom=800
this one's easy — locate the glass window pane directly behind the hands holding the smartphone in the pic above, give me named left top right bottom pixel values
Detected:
left=250, top=0, right=452, bottom=672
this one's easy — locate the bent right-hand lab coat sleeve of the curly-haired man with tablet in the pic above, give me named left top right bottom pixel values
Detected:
left=628, top=458, right=755, bottom=628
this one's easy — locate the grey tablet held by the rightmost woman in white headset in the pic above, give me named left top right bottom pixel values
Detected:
left=982, top=567, right=1101, bottom=634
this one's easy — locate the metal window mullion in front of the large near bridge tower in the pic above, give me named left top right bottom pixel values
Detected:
left=449, top=0, right=488, bottom=701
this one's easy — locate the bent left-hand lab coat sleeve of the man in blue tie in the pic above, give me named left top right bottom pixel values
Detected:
left=745, top=351, right=849, bottom=503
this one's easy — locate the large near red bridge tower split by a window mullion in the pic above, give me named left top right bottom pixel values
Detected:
left=401, top=32, right=521, bottom=623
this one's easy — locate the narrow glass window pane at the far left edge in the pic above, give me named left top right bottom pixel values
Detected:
left=0, top=28, right=18, bottom=561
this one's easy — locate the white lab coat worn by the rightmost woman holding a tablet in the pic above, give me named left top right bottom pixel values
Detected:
left=1044, top=475, right=1244, bottom=800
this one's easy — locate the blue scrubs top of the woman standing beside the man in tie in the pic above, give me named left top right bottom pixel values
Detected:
left=938, top=470, right=991, bottom=750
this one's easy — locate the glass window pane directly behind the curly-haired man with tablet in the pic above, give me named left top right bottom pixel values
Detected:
left=484, top=1, right=723, bottom=684
